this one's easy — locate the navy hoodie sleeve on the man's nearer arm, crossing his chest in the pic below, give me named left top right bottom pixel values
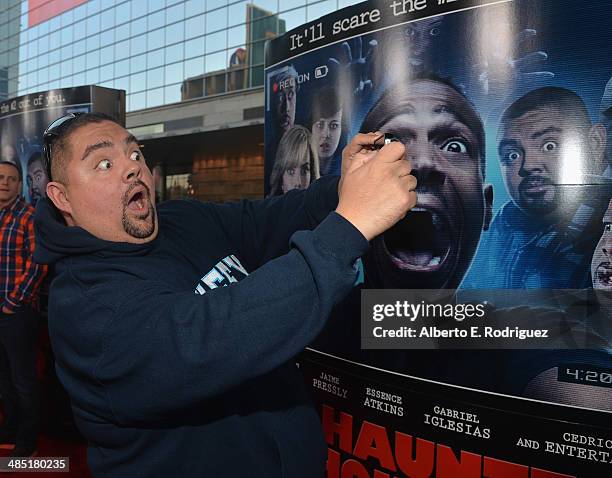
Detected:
left=94, top=213, right=368, bottom=425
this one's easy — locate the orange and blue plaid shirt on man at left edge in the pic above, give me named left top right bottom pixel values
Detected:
left=0, top=197, right=47, bottom=312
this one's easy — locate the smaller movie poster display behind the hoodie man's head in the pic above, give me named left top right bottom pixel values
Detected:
left=0, top=86, right=125, bottom=205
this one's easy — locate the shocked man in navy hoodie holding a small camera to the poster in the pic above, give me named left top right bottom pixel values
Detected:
left=36, top=114, right=416, bottom=478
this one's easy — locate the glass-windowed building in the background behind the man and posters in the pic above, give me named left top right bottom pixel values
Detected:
left=0, top=0, right=358, bottom=200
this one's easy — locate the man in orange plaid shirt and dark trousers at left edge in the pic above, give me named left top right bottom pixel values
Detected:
left=0, top=161, right=47, bottom=456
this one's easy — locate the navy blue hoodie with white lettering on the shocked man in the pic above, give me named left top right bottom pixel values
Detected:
left=35, top=178, right=367, bottom=478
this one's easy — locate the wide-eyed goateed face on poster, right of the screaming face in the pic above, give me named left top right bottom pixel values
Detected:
left=498, top=106, right=595, bottom=217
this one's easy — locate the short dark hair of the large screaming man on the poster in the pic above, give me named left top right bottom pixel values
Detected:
left=360, top=73, right=486, bottom=179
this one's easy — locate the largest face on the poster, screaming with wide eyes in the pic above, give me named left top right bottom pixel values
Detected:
left=362, top=80, right=492, bottom=289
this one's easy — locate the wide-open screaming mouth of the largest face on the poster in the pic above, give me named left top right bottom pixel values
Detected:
left=383, top=208, right=451, bottom=272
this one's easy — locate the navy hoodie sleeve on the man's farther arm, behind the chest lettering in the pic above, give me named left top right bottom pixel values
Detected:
left=206, top=176, right=339, bottom=270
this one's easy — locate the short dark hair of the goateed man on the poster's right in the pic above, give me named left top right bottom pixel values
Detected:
left=500, top=86, right=593, bottom=129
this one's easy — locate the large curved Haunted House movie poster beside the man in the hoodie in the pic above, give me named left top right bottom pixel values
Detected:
left=265, top=0, right=612, bottom=478
